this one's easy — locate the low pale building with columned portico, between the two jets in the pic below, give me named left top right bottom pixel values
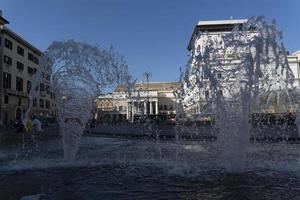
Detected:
left=96, top=82, right=180, bottom=121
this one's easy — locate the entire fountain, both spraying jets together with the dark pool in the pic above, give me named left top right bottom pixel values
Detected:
left=0, top=17, right=300, bottom=200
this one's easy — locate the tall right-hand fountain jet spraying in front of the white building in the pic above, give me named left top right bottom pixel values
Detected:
left=179, top=17, right=293, bottom=172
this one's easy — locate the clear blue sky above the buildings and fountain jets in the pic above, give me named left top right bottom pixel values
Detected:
left=0, top=0, right=300, bottom=81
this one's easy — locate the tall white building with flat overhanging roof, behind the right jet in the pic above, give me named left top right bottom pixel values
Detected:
left=183, top=19, right=250, bottom=116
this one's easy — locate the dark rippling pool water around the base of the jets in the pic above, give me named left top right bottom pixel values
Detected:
left=0, top=137, right=300, bottom=200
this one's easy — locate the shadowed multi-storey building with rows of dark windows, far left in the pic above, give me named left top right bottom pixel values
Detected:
left=0, top=13, right=54, bottom=124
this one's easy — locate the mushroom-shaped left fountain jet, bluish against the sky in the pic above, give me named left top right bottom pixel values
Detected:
left=26, top=40, right=131, bottom=161
